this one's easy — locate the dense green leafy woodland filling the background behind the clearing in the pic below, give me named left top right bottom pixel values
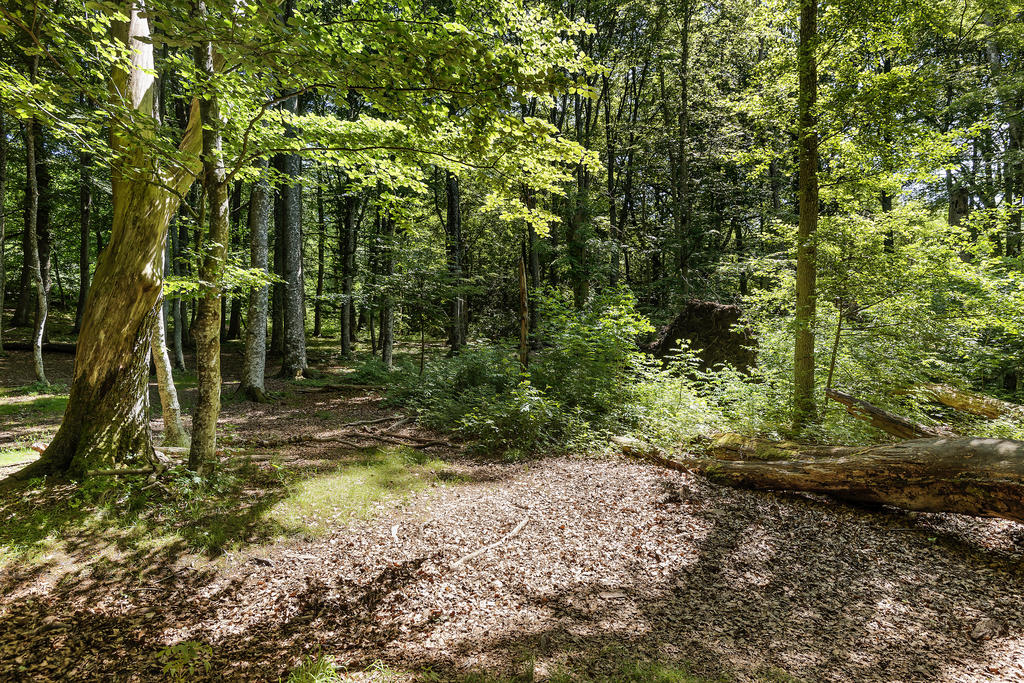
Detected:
left=0, top=0, right=1024, bottom=458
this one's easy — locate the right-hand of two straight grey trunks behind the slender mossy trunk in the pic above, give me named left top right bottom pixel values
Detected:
left=281, top=90, right=306, bottom=379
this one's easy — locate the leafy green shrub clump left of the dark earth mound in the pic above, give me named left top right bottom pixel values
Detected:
left=388, top=290, right=720, bottom=454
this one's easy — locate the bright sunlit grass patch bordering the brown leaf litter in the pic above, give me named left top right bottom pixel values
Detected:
left=267, top=446, right=444, bottom=535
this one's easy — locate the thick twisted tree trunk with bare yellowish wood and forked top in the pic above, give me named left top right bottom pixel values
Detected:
left=7, top=6, right=201, bottom=479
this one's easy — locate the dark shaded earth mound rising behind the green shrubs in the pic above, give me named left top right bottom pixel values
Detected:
left=647, top=300, right=757, bottom=371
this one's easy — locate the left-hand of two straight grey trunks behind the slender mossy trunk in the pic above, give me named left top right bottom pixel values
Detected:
left=240, top=161, right=273, bottom=402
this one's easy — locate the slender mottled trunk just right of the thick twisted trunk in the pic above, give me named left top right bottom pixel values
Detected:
left=188, top=12, right=230, bottom=471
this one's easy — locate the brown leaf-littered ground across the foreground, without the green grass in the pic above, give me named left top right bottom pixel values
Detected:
left=0, top=350, right=1024, bottom=681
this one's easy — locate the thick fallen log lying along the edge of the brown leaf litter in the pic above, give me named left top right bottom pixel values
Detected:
left=613, top=434, right=1024, bottom=522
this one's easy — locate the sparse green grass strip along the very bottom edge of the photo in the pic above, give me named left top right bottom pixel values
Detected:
left=286, top=649, right=724, bottom=683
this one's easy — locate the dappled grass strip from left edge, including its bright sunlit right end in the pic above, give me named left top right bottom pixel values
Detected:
left=0, top=446, right=455, bottom=568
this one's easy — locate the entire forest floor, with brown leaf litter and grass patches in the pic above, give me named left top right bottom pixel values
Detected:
left=0, top=342, right=1024, bottom=682
